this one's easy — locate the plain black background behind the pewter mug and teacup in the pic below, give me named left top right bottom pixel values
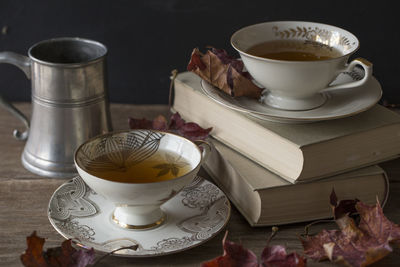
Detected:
left=0, top=0, right=400, bottom=104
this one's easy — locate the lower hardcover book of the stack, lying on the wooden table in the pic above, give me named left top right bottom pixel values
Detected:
left=203, top=139, right=388, bottom=226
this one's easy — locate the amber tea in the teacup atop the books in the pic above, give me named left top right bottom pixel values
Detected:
left=246, top=40, right=342, bottom=61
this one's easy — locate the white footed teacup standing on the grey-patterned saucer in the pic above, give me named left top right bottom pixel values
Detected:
left=75, top=130, right=210, bottom=229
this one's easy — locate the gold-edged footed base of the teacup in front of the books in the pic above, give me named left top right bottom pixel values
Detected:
left=111, top=207, right=167, bottom=230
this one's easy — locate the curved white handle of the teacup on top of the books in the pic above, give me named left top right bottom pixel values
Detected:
left=322, top=57, right=372, bottom=92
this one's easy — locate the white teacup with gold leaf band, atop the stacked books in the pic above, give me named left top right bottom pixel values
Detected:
left=231, top=21, right=372, bottom=110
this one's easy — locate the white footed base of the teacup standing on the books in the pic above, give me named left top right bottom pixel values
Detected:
left=262, top=92, right=328, bottom=111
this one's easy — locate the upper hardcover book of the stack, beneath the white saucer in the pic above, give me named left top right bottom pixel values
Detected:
left=172, top=72, right=400, bottom=183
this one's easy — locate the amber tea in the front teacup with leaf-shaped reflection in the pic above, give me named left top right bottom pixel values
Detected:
left=87, top=150, right=192, bottom=183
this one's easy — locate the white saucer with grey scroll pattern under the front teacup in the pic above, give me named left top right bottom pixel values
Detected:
left=48, top=176, right=231, bottom=257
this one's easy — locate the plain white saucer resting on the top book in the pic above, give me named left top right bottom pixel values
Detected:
left=201, top=69, right=382, bottom=123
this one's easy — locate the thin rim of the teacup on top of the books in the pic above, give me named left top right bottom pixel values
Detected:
left=230, top=20, right=360, bottom=64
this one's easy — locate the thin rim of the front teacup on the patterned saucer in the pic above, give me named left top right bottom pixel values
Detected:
left=74, top=129, right=202, bottom=185
